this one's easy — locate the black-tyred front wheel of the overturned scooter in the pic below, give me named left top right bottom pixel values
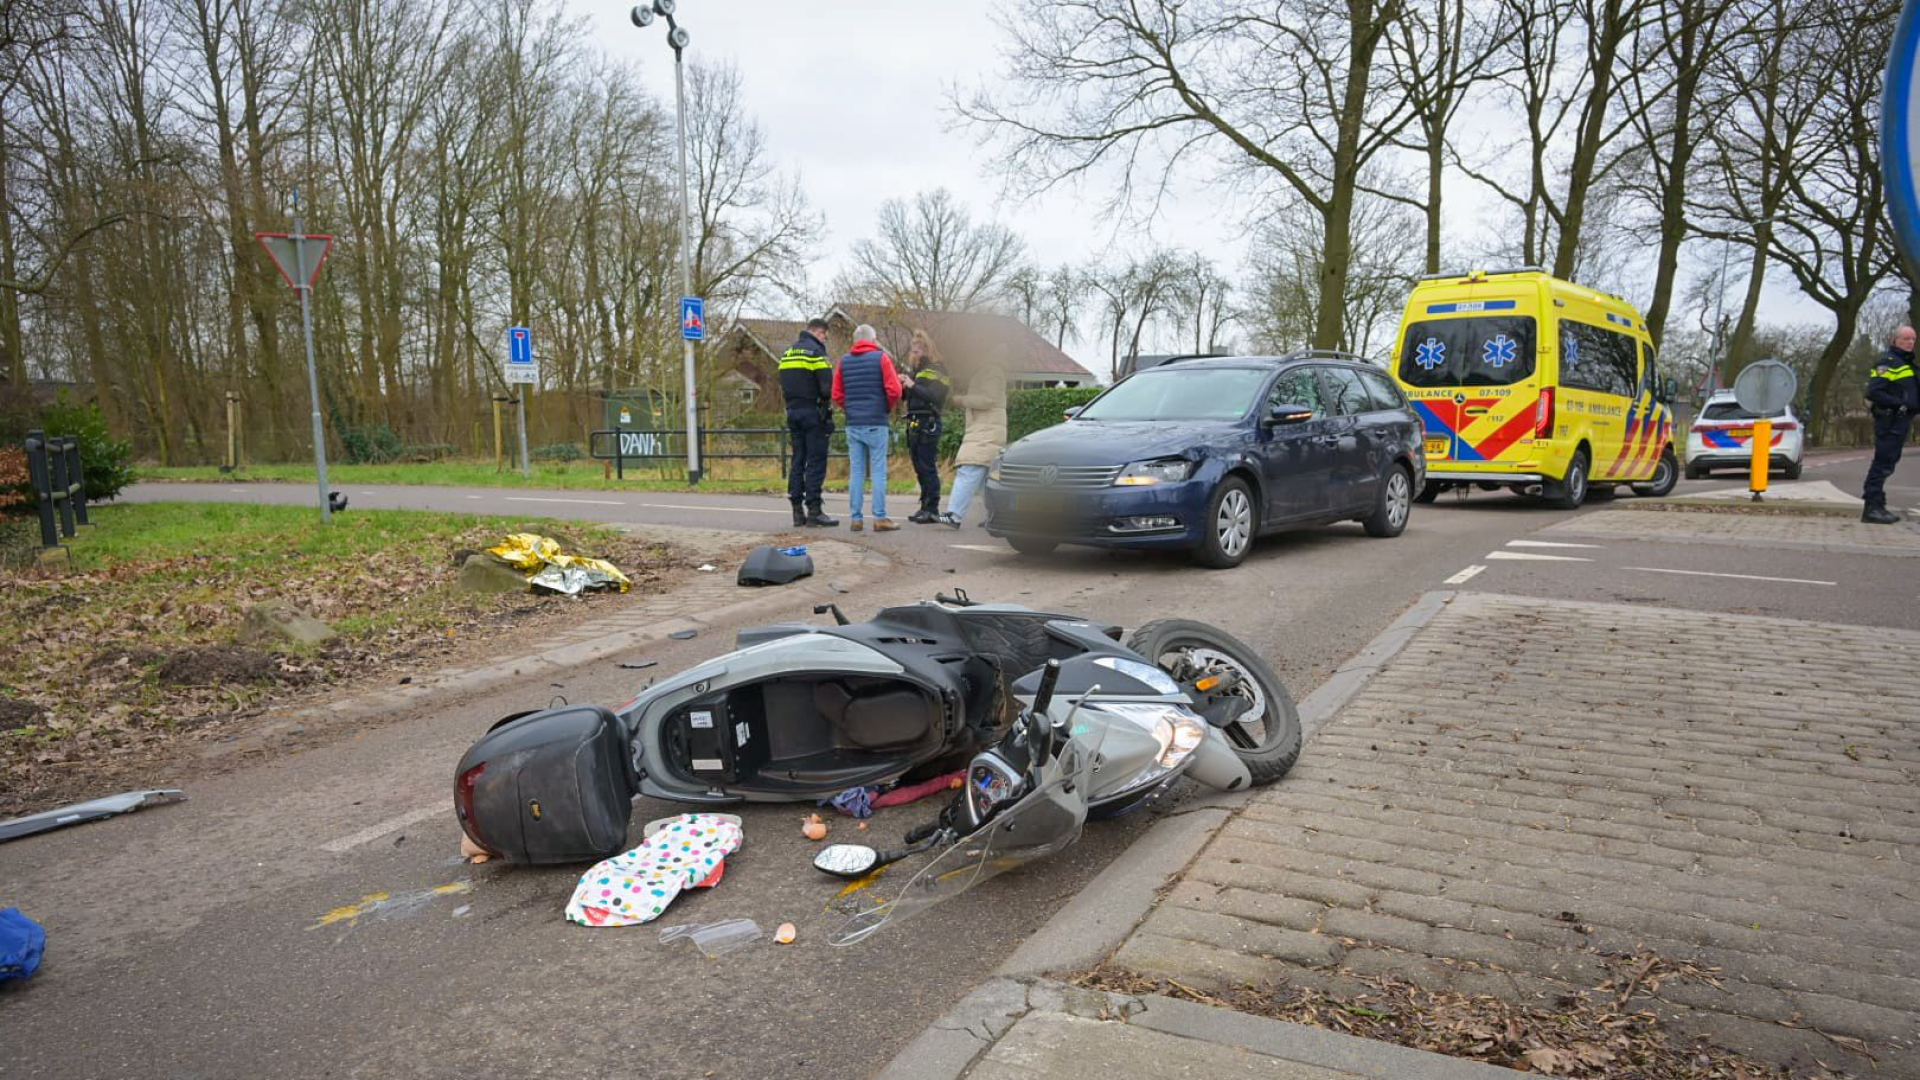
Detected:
left=1127, top=619, right=1300, bottom=786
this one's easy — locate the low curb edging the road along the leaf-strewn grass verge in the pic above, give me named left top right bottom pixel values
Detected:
left=200, top=544, right=893, bottom=759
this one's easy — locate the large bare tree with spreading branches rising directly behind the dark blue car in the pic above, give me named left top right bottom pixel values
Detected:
left=956, top=0, right=1413, bottom=346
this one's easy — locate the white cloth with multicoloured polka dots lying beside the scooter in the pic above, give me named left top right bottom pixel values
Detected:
left=566, top=813, right=741, bottom=926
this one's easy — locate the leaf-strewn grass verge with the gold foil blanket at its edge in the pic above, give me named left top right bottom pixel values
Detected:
left=0, top=503, right=684, bottom=813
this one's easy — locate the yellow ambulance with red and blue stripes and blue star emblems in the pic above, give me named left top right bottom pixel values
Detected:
left=1392, top=267, right=1680, bottom=509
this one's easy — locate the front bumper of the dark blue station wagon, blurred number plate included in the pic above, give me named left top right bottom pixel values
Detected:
left=987, top=479, right=1213, bottom=548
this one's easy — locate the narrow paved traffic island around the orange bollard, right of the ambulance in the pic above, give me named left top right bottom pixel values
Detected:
left=1546, top=509, right=1920, bottom=555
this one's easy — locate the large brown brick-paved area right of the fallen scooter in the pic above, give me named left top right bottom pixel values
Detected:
left=1114, top=591, right=1920, bottom=1076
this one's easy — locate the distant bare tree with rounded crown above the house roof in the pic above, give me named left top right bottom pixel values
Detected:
left=849, top=188, right=1025, bottom=311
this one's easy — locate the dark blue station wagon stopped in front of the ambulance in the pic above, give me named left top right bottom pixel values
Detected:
left=987, top=352, right=1427, bottom=569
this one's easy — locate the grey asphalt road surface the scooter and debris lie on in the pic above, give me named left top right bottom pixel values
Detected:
left=0, top=447, right=1920, bottom=1080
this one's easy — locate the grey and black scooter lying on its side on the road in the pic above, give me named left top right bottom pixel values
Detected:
left=455, top=594, right=1300, bottom=863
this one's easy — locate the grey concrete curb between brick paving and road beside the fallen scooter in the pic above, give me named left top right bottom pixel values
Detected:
left=877, top=590, right=1451, bottom=1080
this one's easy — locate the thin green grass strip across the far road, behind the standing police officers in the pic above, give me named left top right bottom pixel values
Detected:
left=138, top=457, right=929, bottom=494
